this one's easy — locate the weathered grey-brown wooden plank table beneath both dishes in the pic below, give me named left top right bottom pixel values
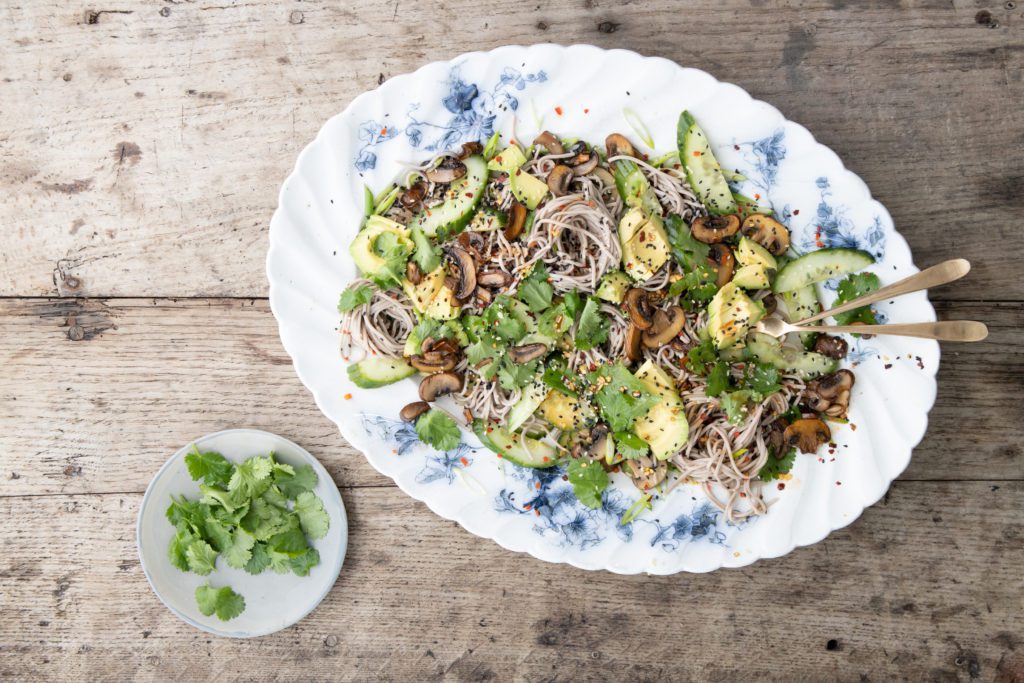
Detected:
left=0, top=0, right=1024, bottom=681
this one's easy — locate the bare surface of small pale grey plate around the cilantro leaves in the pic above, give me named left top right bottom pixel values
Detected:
left=136, top=429, right=348, bottom=638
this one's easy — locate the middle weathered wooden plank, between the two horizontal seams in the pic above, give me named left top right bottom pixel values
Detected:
left=0, top=299, right=1024, bottom=495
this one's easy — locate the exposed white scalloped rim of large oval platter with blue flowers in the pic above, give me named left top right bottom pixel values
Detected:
left=267, top=45, right=939, bottom=573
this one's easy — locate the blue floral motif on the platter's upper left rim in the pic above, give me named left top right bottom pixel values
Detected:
left=352, top=65, right=548, bottom=171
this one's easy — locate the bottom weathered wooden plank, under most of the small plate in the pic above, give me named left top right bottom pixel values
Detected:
left=0, top=482, right=1024, bottom=681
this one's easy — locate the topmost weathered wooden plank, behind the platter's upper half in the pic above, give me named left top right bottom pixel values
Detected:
left=0, top=0, right=1024, bottom=300
